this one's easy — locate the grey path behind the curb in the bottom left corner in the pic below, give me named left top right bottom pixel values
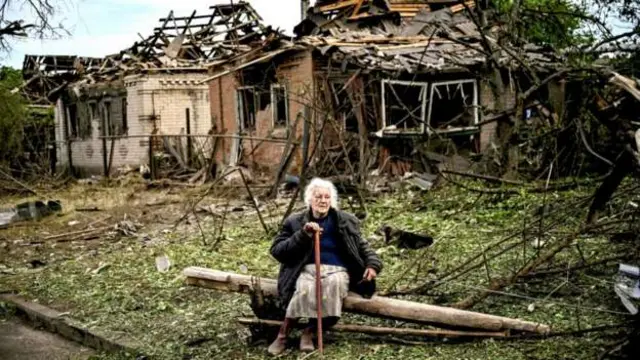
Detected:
left=0, top=317, right=94, bottom=360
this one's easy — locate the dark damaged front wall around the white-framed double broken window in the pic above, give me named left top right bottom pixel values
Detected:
left=315, top=64, right=502, bottom=175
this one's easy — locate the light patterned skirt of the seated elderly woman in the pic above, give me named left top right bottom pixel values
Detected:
left=286, top=264, right=349, bottom=318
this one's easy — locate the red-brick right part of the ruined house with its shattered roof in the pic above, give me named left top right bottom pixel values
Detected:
left=207, top=0, right=555, bottom=176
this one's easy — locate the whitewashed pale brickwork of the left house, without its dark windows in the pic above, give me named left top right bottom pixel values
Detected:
left=55, top=74, right=212, bottom=173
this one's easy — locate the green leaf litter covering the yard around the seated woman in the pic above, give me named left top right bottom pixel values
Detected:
left=0, top=180, right=628, bottom=360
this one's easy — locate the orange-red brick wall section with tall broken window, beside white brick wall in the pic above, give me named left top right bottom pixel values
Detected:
left=209, top=51, right=313, bottom=173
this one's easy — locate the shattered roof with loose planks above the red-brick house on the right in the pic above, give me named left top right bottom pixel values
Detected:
left=295, top=0, right=558, bottom=73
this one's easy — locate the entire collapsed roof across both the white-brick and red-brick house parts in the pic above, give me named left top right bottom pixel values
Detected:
left=20, top=0, right=559, bottom=102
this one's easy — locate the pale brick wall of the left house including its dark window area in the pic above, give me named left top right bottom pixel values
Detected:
left=56, top=73, right=212, bottom=173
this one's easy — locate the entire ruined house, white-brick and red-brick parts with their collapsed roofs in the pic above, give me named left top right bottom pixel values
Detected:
left=45, top=0, right=556, bottom=179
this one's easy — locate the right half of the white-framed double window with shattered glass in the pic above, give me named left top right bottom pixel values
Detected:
left=428, top=80, right=478, bottom=133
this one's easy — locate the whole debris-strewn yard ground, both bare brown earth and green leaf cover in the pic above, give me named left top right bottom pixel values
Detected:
left=0, top=173, right=630, bottom=360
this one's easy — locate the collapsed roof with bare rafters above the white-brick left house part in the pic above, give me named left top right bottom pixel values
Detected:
left=23, top=1, right=282, bottom=98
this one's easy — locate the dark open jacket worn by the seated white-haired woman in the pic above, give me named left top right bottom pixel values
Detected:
left=271, top=208, right=382, bottom=308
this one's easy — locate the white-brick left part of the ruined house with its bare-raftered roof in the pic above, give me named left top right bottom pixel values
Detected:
left=45, top=2, right=278, bottom=174
